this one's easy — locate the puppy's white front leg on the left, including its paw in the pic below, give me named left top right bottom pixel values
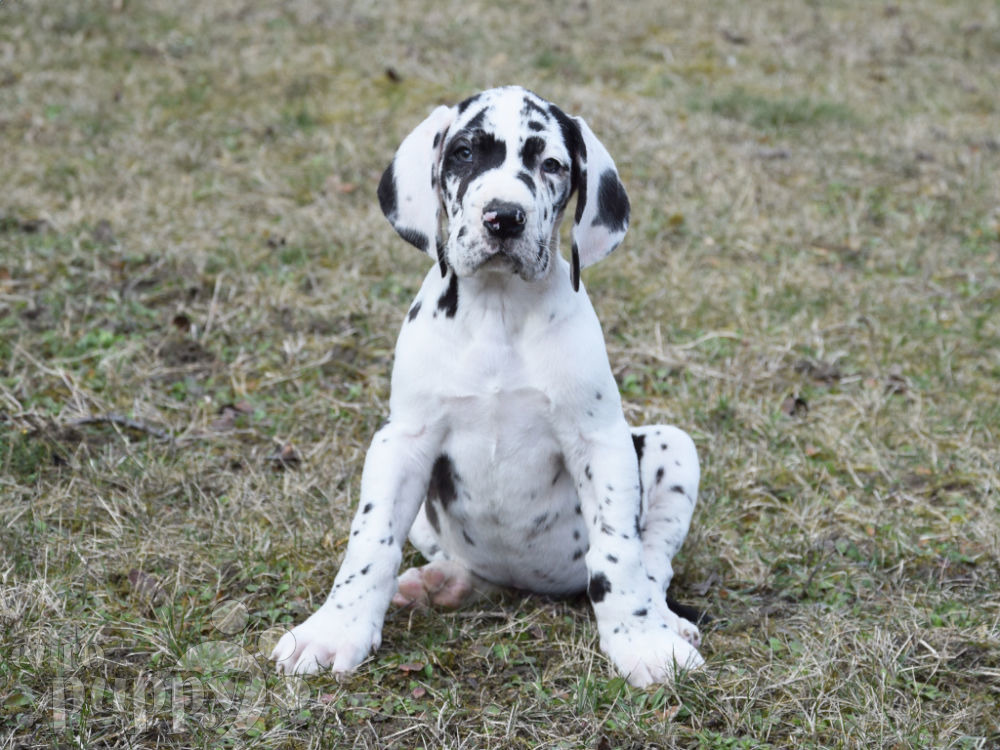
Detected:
left=271, top=423, right=436, bottom=674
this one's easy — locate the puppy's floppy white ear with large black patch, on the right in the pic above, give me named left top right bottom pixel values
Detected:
left=572, top=117, right=629, bottom=290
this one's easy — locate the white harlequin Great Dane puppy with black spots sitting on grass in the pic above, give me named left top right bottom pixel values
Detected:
left=272, top=87, right=703, bottom=686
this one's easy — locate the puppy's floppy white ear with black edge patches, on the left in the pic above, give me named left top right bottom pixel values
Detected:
left=378, top=107, right=455, bottom=272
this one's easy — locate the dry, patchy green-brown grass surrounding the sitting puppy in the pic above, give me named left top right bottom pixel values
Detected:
left=0, top=0, right=1000, bottom=749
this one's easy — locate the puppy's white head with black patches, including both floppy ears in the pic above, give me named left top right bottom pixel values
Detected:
left=378, top=86, right=629, bottom=288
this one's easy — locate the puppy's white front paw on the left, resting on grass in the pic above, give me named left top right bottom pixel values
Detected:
left=271, top=604, right=382, bottom=674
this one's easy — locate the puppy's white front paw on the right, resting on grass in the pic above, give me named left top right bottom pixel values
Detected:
left=599, top=623, right=705, bottom=688
